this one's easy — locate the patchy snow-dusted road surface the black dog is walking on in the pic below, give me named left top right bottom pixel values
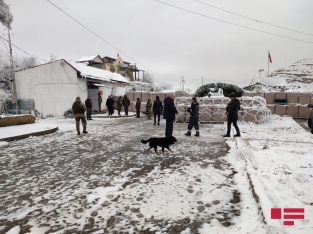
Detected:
left=0, top=117, right=241, bottom=233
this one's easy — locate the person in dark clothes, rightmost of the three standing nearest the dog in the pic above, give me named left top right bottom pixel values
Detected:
left=223, top=93, right=240, bottom=137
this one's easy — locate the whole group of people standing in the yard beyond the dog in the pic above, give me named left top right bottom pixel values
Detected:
left=72, top=92, right=241, bottom=137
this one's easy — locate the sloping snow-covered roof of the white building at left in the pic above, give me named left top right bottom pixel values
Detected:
left=66, top=61, right=129, bottom=83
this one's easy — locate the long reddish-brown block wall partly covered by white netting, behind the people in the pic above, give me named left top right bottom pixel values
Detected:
left=126, top=91, right=313, bottom=122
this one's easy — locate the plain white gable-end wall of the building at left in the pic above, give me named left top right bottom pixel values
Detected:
left=15, top=61, right=87, bottom=116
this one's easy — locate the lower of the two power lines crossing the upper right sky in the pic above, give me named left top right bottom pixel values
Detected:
left=153, top=0, right=313, bottom=44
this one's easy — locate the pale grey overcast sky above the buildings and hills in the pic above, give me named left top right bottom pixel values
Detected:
left=0, top=0, right=313, bottom=90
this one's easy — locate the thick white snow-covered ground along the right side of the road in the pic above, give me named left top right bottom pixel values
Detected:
left=214, top=116, right=313, bottom=234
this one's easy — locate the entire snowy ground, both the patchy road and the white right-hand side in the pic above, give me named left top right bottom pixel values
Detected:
left=0, top=116, right=313, bottom=233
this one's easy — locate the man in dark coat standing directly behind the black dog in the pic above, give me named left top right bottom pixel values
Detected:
left=163, top=95, right=178, bottom=137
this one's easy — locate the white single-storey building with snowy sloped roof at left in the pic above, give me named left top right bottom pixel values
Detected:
left=15, top=59, right=129, bottom=116
